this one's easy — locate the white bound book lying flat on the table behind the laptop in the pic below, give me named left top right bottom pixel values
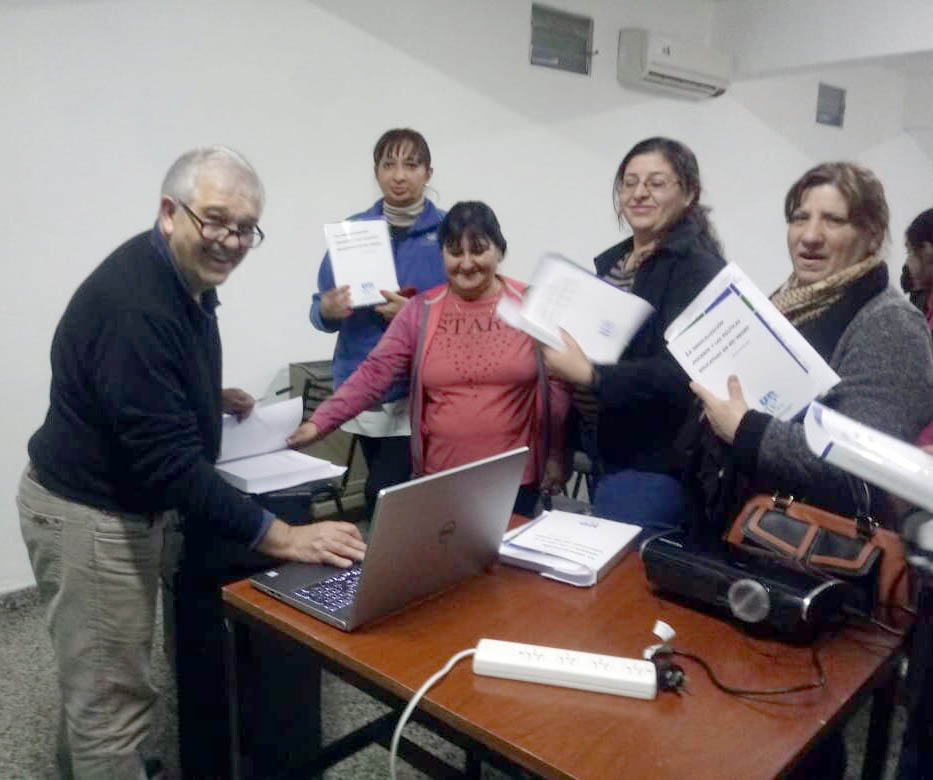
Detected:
left=499, top=511, right=641, bottom=587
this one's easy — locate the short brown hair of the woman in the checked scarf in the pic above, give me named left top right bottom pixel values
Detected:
left=784, top=162, right=888, bottom=248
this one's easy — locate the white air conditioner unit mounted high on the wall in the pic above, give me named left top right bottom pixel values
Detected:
left=618, top=27, right=732, bottom=98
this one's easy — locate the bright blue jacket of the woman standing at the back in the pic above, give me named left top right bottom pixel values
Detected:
left=311, top=200, right=447, bottom=403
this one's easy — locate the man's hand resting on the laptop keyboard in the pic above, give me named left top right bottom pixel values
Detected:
left=257, top=518, right=366, bottom=568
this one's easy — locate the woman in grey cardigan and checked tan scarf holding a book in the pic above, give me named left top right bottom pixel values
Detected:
left=687, top=162, right=933, bottom=536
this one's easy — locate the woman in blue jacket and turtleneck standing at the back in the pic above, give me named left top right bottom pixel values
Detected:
left=311, top=128, right=445, bottom=516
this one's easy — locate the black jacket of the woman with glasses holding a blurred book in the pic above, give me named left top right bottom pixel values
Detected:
left=594, top=210, right=725, bottom=473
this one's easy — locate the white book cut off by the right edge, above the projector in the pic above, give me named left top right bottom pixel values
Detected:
left=803, top=402, right=933, bottom=512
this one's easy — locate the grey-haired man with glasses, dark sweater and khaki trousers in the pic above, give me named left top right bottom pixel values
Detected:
left=17, top=146, right=365, bottom=778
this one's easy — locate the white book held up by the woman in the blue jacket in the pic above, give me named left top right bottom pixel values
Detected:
left=324, top=219, right=399, bottom=309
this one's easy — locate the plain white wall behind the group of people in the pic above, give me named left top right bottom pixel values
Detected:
left=0, top=0, right=933, bottom=592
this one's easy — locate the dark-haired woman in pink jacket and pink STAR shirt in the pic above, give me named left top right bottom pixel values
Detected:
left=289, top=201, right=569, bottom=515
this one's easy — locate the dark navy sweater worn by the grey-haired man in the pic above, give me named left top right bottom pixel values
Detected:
left=29, top=231, right=263, bottom=544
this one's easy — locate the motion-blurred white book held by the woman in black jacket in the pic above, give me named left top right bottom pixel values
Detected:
left=497, top=253, right=653, bottom=364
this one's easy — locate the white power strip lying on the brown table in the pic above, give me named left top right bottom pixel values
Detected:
left=473, top=639, right=658, bottom=699
